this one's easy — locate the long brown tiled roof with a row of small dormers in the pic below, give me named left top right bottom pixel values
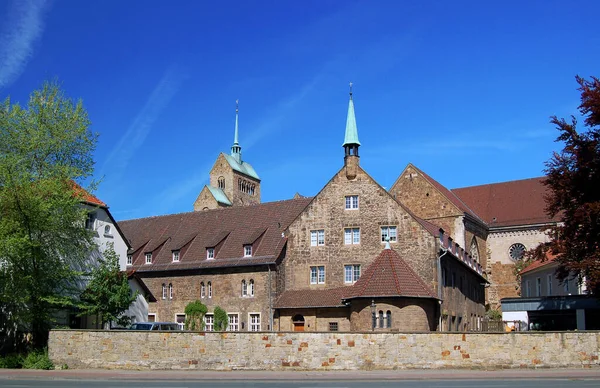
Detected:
left=119, top=198, right=312, bottom=272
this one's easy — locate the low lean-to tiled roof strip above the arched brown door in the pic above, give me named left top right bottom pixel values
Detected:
left=273, top=286, right=350, bottom=309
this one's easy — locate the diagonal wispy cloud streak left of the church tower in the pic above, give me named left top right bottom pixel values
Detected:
left=102, top=67, right=187, bottom=179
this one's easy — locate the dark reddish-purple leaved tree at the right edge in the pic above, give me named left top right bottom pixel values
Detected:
left=530, top=77, right=600, bottom=293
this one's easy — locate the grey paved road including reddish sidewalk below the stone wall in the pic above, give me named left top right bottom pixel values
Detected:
left=0, top=369, right=600, bottom=388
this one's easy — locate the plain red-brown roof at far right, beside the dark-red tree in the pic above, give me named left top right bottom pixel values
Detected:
left=452, top=177, right=558, bottom=228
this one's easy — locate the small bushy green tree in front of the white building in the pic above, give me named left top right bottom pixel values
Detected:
left=78, top=244, right=138, bottom=328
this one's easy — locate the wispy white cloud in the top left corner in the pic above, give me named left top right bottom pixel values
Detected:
left=0, top=0, right=47, bottom=89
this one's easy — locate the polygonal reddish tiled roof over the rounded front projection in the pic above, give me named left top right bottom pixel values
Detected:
left=345, top=248, right=437, bottom=299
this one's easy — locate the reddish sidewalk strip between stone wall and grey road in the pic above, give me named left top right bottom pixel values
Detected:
left=0, top=368, right=600, bottom=381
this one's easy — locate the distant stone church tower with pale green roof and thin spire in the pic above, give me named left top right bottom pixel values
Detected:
left=194, top=101, right=260, bottom=211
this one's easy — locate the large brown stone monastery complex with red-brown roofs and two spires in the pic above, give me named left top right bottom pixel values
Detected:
left=120, top=91, right=553, bottom=331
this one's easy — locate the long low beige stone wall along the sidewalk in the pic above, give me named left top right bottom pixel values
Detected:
left=49, top=330, right=600, bottom=370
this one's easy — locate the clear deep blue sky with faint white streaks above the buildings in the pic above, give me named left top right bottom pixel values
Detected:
left=0, top=0, right=600, bottom=220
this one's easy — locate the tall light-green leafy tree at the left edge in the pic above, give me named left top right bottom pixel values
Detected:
left=0, top=82, right=96, bottom=346
